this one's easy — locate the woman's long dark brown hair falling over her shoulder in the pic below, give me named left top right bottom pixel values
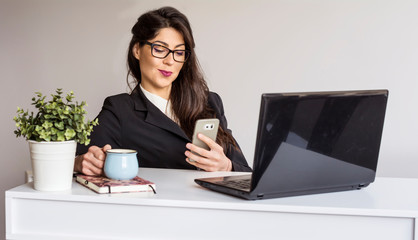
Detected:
left=127, top=7, right=237, bottom=150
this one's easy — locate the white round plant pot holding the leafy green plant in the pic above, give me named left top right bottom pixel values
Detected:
left=28, top=140, right=77, bottom=191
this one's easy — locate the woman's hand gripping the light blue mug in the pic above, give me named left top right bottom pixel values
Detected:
left=74, top=144, right=112, bottom=176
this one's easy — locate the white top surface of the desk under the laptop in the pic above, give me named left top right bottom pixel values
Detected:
left=6, top=168, right=418, bottom=217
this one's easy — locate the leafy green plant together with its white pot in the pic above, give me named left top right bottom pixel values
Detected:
left=13, top=88, right=98, bottom=191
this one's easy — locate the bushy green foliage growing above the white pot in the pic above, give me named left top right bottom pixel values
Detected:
left=13, top=88, right=98, bottom=145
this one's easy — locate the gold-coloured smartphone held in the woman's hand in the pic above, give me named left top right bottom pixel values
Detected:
left=190, top=118, right=219, bottom=161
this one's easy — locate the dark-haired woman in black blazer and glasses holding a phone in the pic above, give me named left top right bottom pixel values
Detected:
left=74, top=7, right=251, bottom=175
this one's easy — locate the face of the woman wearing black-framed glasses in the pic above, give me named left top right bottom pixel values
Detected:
left=133, top=28, right=186, bottom=99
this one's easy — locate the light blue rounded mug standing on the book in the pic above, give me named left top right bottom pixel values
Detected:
left=104, top=149, right=138, bottom=180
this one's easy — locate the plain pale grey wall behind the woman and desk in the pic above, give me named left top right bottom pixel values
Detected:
left=0, top=0, right=418, bottom=238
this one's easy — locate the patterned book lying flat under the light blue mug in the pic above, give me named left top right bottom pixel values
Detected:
left=76, top=174, right=156, bottom=193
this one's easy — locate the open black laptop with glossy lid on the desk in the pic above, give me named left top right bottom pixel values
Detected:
left=195, top=90, right=388, bottom=200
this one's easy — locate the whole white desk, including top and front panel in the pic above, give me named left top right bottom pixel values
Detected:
left=5, top=168, right=418, bottom=240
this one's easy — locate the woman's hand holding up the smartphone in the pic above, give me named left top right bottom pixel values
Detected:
left=185, top=133, right=232, bottom=172
